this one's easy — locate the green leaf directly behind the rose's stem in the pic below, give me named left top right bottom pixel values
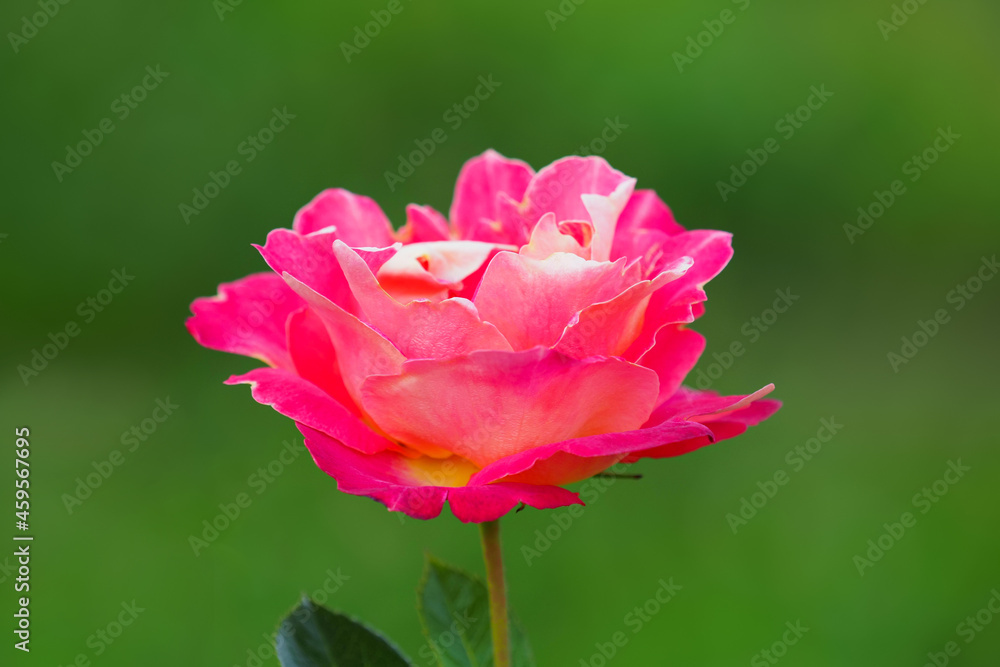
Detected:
left=417, top=557, right=535, bottom=667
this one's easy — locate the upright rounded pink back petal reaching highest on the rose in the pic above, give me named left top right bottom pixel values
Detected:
left=450, top=150, right=534, bottom=244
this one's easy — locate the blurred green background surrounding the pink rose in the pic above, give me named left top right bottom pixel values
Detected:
left=0, top=0, right=1000, bottom=667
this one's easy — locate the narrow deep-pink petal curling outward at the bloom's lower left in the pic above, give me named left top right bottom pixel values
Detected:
left=226, top=368, right=399, bottom=454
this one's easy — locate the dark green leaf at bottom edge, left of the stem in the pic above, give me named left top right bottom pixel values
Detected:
left=277, top=597, right=412, bottom=667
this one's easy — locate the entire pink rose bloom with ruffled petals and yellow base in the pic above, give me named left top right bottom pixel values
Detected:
left=187, top=151, right=780, bottom=522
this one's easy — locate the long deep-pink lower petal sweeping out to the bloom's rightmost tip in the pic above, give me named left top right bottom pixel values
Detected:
left=470, top=385, right=778, bottom=484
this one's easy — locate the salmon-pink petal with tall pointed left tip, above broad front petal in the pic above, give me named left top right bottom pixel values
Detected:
left=334, top=241, right=511, bottom=359
